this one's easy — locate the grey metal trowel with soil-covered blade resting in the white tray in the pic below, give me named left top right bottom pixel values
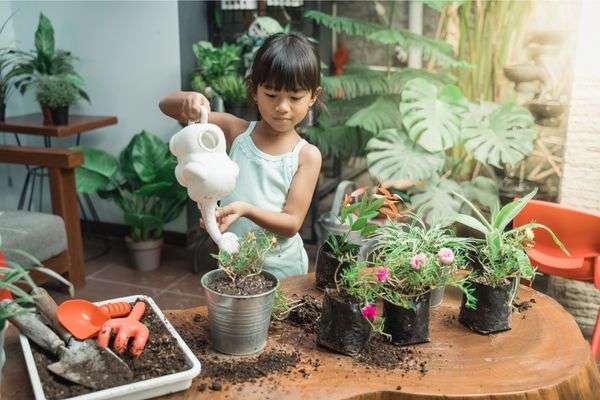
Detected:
left=5, top=296, right=133, bottom=390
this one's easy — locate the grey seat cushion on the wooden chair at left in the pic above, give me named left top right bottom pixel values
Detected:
left=0, top=211, right=67, bottom=267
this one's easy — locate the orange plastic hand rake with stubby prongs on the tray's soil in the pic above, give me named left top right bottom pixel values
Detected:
left=96, top=301, right=150, bottom=357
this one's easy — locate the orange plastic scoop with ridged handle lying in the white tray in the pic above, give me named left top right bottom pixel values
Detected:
left=56, top=299, right=131, bottom=340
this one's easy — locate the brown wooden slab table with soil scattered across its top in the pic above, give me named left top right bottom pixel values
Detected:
left=0, top=274, right=600, bottom=400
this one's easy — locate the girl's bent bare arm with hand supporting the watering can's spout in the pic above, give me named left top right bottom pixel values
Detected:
left=217, top=144, right=321, bottom=237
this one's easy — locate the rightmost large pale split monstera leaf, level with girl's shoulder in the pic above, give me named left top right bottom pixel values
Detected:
left=462, top=103, right=536, bottom=168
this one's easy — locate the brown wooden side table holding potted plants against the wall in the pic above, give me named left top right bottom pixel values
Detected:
left=0, top=113, right=118, bottom=214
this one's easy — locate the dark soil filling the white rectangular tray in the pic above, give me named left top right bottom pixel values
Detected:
left=30, top=303, right=191, bottom=400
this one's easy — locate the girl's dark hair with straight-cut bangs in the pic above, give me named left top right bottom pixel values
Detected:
left=247, top=32, right=321, bottom=94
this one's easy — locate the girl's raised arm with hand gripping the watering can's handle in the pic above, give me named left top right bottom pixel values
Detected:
left=158, top=91, right=248, bottom=146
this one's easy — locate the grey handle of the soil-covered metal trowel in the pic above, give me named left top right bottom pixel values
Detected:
left=0, top=300, right=65, bottom=355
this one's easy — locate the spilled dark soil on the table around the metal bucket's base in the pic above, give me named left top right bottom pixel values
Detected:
left=170, top=314, right=301, bottom=391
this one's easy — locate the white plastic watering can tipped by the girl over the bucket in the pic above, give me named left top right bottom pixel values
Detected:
left=169, top=107, right=240, bottom=254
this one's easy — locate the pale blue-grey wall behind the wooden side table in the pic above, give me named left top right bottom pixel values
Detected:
left=0, top=1, right=185, bottom=232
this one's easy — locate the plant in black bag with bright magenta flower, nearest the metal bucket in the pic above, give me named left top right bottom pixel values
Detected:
left=317, top=260, right=383, bottom=356
